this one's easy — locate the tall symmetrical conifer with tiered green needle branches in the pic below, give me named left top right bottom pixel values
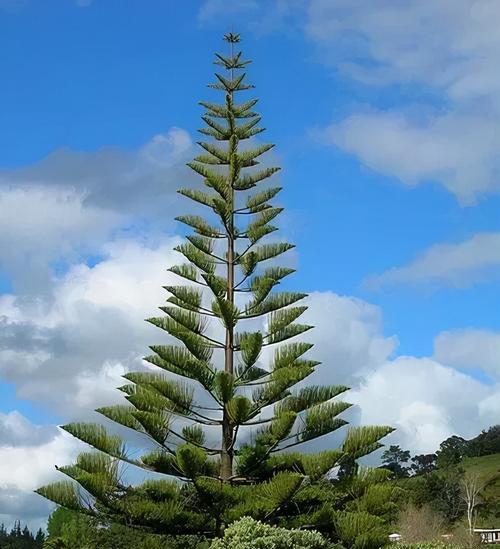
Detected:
left=38, top=34, right=392, bottom=537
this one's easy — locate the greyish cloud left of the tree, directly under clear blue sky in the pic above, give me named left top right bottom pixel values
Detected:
left=0, top=128, right=194, bottom=296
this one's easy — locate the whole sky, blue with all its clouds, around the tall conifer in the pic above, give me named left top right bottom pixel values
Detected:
left=0, top=0, right=500, bottom=528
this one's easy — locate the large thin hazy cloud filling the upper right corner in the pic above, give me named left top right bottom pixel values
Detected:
left=305, top=0, right=500, bottom=203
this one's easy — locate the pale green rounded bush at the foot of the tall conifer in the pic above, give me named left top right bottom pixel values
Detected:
left=210, top=517, right=333, bottom=549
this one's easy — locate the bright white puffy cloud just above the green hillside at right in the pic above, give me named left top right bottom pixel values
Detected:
left=349, top=357, right=496, bottom=453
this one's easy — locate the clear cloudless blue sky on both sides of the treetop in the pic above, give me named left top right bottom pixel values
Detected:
left=0, top=1, right=500, bottom=355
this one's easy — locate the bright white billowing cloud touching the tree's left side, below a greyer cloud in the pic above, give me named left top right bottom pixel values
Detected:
left=0, top=237, right=184, bottom=418
